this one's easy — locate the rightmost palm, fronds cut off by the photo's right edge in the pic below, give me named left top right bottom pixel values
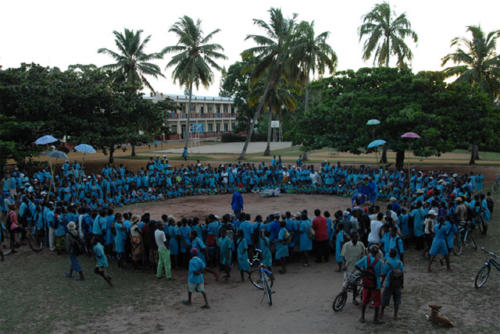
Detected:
left=441, top=26, right=500, bottom=165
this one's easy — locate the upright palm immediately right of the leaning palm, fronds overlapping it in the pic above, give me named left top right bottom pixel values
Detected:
left=293, top=21, right=337, bottom=160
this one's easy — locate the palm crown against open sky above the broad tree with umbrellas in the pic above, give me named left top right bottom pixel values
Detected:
left=358, top=2, right=418, bottom=67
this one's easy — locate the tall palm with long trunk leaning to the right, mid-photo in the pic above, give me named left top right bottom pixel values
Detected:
left=238, top=8, right=297, bottom=160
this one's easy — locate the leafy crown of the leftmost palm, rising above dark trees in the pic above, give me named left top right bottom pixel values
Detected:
left=97, top=29, right=163, bottom=92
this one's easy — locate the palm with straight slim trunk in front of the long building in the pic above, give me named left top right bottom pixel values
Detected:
left=162, top=15, right=226, bottom=152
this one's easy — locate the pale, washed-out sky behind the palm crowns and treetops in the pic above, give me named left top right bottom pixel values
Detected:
left=0, top=0, right=500, bottom=96
